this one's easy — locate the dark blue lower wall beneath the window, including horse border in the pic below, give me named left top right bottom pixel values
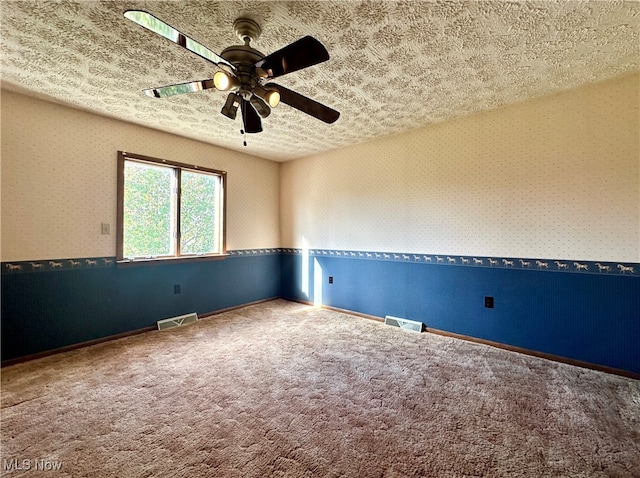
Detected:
left=2, top=249, right=281, bottom=361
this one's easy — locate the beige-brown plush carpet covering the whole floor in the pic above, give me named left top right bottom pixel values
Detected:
left=1, top=300, right=640, bottom=478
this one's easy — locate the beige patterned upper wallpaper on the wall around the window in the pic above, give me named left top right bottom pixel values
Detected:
left=1, top=90, right=280, bottom=261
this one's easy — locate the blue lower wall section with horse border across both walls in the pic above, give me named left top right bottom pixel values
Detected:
left=2, top=249, right=640, bottom=374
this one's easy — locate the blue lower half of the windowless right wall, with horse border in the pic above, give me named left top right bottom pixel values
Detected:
left=282, top=250, right=640, bottom=373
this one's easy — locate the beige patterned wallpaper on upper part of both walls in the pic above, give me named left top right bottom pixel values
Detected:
left=1, top=75, right=640, bottom=262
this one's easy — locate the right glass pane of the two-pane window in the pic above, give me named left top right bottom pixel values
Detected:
left=180, top=171, right=220, bottom=254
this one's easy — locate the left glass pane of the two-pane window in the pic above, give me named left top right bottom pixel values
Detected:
left=123, top=161, right=175, bottom=257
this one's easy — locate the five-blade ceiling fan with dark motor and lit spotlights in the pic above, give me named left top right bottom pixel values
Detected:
left=124, top=10, right=340, bottom=133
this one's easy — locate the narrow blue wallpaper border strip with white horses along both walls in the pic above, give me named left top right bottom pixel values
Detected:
left=1, top=247, right=640, bottom=277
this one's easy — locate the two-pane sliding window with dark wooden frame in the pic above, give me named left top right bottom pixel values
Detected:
left=116, top=151, right=226, bottom=262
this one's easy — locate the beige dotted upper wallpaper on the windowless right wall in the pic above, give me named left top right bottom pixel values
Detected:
left=281, top=74, right=640, bottom=262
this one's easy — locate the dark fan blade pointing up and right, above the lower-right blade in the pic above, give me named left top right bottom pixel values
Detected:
left=255, top=36, right=329, bottom=78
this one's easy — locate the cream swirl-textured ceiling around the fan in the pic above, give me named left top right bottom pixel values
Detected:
left=1, top=0, right=640, bottom=161
